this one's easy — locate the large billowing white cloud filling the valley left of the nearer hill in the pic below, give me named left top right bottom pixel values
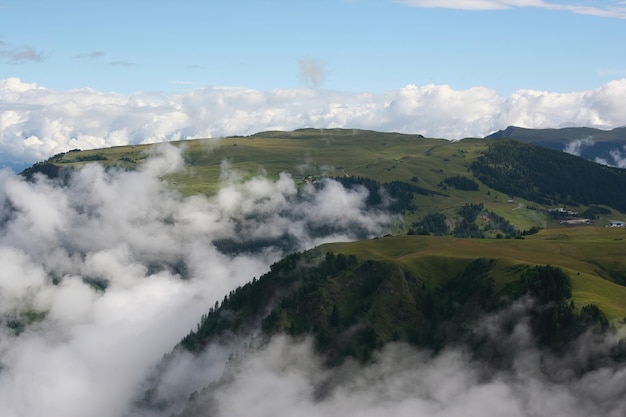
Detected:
left=0, top=144, right=391, bottom=417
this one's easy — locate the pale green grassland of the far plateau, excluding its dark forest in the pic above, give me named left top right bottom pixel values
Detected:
left=47, top=129, right=584, bottom=230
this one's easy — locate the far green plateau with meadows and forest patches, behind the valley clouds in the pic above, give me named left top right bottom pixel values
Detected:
left=23, top=129, right=625, bottom=237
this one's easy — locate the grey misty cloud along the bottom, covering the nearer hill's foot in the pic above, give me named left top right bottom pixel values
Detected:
left=136, top=299, right=626, bottom=417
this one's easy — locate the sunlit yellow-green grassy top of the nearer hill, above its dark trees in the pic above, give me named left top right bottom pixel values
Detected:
left=323, top=227, right=626, bottom=321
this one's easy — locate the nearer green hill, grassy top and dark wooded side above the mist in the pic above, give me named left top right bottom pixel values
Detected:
left=176, top=224, right=626, bottom=363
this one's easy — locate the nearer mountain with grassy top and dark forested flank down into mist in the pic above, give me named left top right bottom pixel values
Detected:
left=137, top=229, right=626, bottom=416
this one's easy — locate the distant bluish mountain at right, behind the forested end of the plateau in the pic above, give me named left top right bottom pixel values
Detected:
left=486, top=126, right=626, bottom=168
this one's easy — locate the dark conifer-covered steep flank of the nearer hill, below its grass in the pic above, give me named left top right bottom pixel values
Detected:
left=180, top=245, right=610, bottom=364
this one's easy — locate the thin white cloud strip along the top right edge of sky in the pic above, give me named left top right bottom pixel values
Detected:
left=396, top=0, right=626, bottom=19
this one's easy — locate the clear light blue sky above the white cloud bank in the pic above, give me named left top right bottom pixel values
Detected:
left=0, top=0, right=626, bottom=94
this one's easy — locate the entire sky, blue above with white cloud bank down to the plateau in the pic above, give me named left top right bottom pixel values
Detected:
left=0, top=0, right=626, bottom=167
